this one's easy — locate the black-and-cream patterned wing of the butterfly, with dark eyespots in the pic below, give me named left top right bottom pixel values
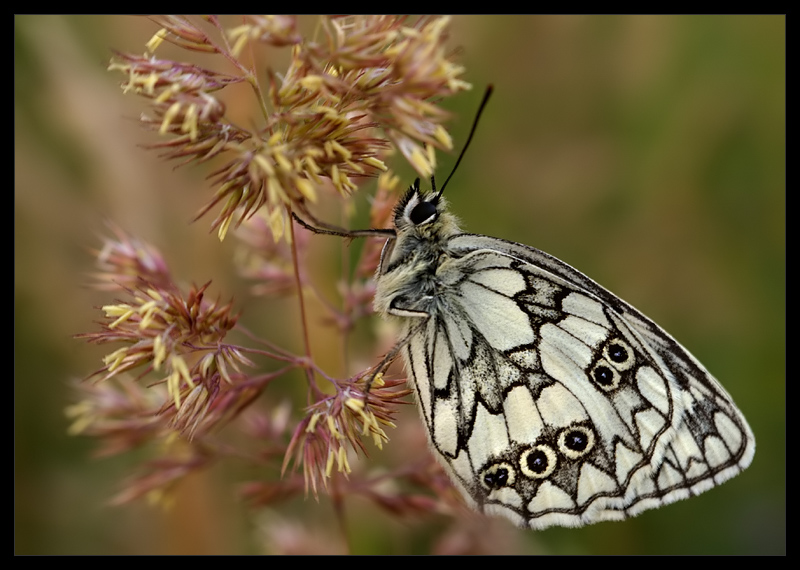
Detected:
left=404, top=234, right=755, bottom=529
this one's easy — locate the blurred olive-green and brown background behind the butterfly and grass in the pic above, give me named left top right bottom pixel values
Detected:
left=14, top=16, right=786, bottom=554
